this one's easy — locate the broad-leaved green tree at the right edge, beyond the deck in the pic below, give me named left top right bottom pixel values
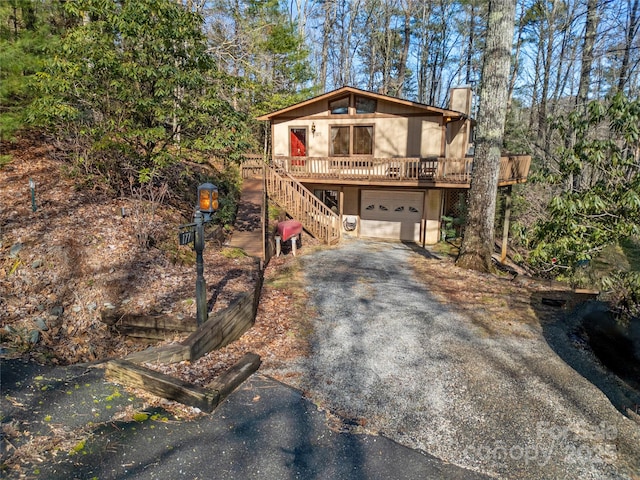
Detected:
left=529, top=93, right=640, bottom=315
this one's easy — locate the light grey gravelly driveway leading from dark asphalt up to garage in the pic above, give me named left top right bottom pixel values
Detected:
left=276, top=239, right=640, bottom=479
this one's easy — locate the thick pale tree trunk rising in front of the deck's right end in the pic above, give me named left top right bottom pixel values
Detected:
left=456, top=0, right=515, bottom=272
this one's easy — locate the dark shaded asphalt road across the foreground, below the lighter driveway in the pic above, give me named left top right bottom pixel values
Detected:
left=0, top=359, right=487, bottom=480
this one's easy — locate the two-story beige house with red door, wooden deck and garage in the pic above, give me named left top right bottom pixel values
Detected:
left=258, top=87, right=531, bottom=244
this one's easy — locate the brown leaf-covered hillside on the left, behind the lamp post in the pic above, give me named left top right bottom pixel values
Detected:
left=0, top=138, right=257, bottom=364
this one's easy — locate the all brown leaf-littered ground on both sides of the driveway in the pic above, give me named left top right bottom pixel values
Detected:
left=0, top=138, right=592, bottom=476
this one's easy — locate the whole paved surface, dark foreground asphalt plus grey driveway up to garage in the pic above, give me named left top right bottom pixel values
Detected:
left=0, top=240, right=640, bottom=480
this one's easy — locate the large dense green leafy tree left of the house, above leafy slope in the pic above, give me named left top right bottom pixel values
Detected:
left=31, top=0, right=248, bottom=188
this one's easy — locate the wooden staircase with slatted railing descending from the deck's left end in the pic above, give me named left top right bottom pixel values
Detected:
left=264, top=165, right=340, bottom=245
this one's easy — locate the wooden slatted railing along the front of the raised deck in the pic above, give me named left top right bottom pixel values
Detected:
left=274, top=155, right=531, bottom=184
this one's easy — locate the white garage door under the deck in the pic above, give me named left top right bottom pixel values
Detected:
left=360, top=190, right=424, bottom=242
